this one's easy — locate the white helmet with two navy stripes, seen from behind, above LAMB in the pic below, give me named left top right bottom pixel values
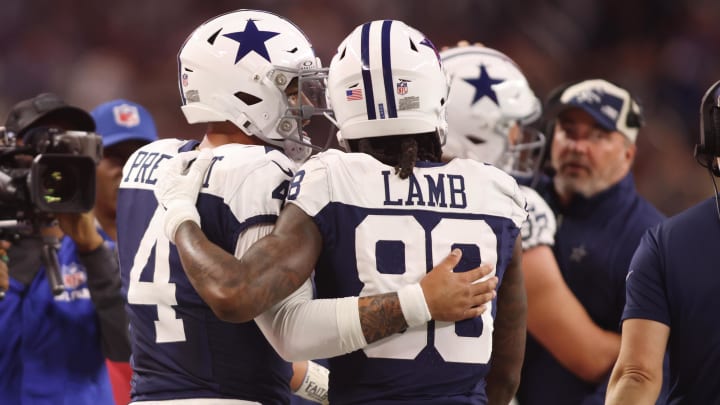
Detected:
left=327, top=20, right=448, bottom=149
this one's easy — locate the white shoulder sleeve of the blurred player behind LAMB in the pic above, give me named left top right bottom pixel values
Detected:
left=520, top=186, right=557, bottom=250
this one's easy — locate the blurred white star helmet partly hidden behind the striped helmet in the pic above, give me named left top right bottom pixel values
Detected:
left=440, top=45, right=545, bottom=177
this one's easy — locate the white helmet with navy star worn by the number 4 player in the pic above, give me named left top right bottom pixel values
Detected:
left=178, top=10, right=328, bottom=160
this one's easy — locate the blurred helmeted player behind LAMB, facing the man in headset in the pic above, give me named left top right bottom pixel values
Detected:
left=440, top=45, right=620, bottom=383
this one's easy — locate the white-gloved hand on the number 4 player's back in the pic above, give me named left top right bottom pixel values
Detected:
left=153, top=149, right=213, bottom=243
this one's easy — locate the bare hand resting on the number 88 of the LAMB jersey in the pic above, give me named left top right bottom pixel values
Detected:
left=420, top=249, right=498, bottom=322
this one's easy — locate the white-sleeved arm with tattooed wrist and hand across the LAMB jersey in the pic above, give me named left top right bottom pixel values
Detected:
left=255, top=238, right=497, bottom=361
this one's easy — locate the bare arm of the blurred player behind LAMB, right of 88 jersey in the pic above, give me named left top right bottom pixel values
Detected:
left=522, top=245, right=620, bottom=383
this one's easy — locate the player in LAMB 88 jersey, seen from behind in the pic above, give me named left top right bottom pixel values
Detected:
left=156, top=20, right=527, bottom=404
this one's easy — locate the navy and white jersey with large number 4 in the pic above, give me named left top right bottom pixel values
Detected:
left=118, top=139, right=292, bottom=404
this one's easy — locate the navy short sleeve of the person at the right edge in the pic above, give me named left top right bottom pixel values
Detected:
left=622, top=228, right=670, bottom=326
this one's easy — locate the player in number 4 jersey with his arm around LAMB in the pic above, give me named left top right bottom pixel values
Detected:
left=118, top=10, right=494, bottom=404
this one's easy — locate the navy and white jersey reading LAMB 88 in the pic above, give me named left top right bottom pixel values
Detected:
left=288, top=151, right=527, bottom=404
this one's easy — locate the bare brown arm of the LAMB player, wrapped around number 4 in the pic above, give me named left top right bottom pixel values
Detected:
left=175, top=205, right=322, bottom=322
